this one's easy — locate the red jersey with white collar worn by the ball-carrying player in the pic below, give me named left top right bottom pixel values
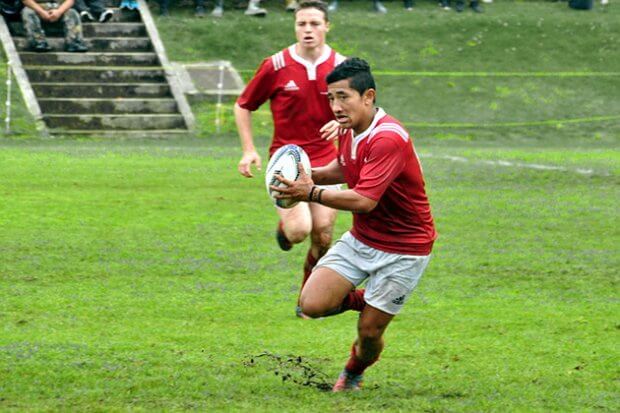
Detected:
left=338, top=109, right=437, bottom=255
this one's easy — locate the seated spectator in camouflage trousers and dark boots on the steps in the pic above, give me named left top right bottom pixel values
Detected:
left=22, top=0, right=88, bottom=52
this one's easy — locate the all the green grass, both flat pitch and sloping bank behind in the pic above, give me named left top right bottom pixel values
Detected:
left=0, top=2, right=620, bottom=412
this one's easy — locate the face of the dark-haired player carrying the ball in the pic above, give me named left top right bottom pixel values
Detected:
left=327, top=79, right=375, bottom=133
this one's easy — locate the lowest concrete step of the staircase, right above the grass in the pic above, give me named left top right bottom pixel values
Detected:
left=43, top=114, right=186, bottom=130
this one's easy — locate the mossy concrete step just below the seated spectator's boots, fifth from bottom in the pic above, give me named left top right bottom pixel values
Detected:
left=19, top=52, right=159, bottom=66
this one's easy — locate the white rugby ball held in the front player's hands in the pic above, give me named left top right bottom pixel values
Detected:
left=265, top=145, right=312, bottom=208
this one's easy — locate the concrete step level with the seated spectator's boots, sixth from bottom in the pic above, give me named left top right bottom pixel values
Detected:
left=13, top=37, right=153, bottom=54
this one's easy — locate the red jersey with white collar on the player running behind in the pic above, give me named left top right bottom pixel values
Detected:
left=237, top=45, right=344, bottom=167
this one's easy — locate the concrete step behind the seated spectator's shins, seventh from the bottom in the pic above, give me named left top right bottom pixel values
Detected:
left=9, top=22, right=147, bottom=38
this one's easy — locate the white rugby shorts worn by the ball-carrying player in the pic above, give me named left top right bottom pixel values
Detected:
left=315, top=231, right=431, bottom=314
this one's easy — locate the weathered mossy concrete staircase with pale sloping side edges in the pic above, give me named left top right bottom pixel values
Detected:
left=0, top=0, right=194, bottom=136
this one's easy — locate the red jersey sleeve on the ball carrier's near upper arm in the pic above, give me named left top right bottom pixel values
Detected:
left=353, top=135, right=405, bottom=202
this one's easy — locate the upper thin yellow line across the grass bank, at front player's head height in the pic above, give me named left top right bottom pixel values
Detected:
left=239, top=69, right=620, bottom=77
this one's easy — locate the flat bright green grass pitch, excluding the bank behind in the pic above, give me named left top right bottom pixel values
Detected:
left=0, top=141, right=620, bottom=411
